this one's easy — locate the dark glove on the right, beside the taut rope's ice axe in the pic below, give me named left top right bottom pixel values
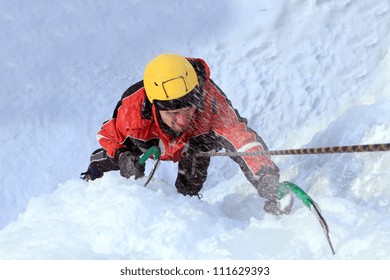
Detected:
left=257, top=173, right=294, bottom=215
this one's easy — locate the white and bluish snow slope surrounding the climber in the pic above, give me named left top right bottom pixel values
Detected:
left=0, top=0, right=390, bottom=260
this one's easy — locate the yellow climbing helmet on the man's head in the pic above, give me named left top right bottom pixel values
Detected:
left=144, top=54, right=199, bottom=103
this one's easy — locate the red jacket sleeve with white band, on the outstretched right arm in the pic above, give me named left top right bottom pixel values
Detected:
left=212, top=82, right=279, bottom=176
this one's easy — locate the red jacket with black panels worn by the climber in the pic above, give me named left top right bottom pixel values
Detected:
left=98, top=58, right=277, bottom=175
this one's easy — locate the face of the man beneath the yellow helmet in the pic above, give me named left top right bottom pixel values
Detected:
left=160, top=106, right=196, bottom=133
